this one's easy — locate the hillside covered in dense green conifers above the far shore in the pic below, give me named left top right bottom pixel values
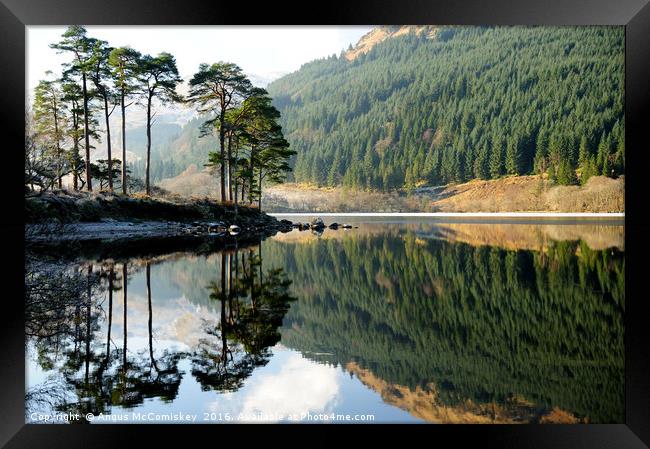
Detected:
left=268, top=27, right=625, bottom=190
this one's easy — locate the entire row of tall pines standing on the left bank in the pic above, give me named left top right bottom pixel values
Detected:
left=25, top=26, right=295, bottom=207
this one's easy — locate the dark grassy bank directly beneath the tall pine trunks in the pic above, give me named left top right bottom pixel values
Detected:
left=25, top=190, right=276, bottom=226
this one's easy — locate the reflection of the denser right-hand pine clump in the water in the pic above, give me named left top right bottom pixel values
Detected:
left=192, top=247, right=295, bottom=391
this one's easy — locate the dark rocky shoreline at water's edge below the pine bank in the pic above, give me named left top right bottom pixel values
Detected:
left=25, top=214, right=356, bottom=260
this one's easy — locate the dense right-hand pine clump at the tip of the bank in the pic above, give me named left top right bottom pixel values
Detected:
left=188, top=62, right=295, bottom=209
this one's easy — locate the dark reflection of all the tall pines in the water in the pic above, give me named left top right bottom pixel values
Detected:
left=25, top=242, right=295, bottom=422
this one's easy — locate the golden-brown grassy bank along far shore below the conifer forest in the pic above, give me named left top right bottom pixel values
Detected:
left=263, top=175, right=625, bottom=212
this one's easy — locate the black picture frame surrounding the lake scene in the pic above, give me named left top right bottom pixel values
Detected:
left=0, top=0, right=650, bottom=449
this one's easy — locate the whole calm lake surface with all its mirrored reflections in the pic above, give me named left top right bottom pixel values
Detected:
left=26, top=217, right=625, bottom=423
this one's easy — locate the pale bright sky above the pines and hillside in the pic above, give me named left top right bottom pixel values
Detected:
left=25, top=26, right=373, bottom=93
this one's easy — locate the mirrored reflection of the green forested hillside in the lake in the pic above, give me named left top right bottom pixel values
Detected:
left=267, top=223, right=625, bottom=422
